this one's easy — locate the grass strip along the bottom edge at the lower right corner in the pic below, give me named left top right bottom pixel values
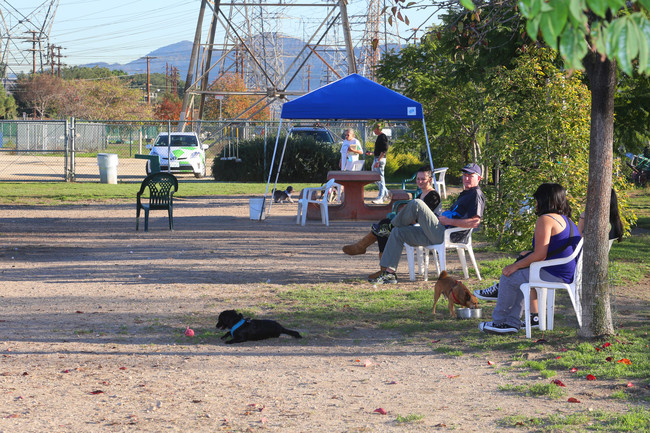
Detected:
left=498, top=408, right=650, bottom=432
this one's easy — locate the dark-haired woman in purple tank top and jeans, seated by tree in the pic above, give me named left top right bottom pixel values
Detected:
left=477, top=183, right=581, bottom=334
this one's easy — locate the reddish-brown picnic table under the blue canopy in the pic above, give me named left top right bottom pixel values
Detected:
left=307, top=170, right=410, bottom=221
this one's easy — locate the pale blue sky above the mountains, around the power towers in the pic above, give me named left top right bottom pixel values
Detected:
left=10, top=0, right=432, bottom=72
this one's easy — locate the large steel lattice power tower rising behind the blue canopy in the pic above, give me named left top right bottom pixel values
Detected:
left=180, top=0, right=386, bottom=128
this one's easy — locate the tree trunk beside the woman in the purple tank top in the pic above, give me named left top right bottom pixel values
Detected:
left=579, top=49, right=616, bottom=338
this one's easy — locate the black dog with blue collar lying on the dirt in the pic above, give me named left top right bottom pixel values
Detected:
left=217, top=310, right=302, bottom=344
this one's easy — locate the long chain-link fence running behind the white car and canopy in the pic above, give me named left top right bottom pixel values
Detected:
left=0, top=119, right=411, bottom=182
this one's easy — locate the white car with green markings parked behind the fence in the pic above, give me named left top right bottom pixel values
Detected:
left=147, top=132, right=209, bottom=178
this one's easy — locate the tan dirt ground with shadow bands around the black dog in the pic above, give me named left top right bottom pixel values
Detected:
left=0, top=196, right=647, bottom=433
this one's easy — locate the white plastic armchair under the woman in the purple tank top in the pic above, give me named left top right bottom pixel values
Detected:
left=519, top=239, right=583, bottom=338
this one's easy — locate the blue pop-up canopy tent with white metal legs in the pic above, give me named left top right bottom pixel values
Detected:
left=260, top=74, right=433, bottom=220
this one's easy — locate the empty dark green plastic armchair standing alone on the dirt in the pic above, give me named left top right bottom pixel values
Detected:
left=135, top=172, right=178, bottom=232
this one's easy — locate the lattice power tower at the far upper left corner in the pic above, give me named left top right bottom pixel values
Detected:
left=0, top=0, right=59, bottom=82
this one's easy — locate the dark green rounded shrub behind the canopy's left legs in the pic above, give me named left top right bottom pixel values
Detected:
left=212, top=137, right=340, bottom=183
